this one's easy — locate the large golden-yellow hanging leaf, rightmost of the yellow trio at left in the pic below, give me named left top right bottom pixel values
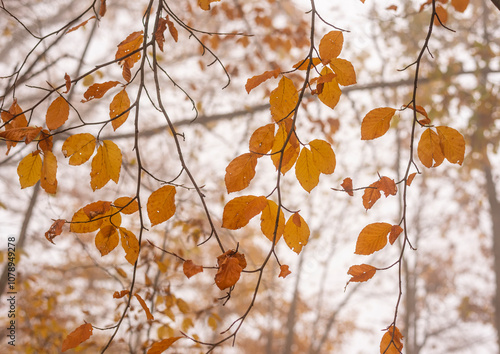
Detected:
left=90, top=140, right=122, bottom=191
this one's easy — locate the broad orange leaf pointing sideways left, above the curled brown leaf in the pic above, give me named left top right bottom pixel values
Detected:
left=222, top=195, right=267, bottom=230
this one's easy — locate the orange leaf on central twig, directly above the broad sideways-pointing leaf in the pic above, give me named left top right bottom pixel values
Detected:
left=224, top=152, right=258, bottom=193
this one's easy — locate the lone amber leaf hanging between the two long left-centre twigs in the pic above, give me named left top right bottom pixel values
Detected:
left=147, top=186, right=176, bottom=226
